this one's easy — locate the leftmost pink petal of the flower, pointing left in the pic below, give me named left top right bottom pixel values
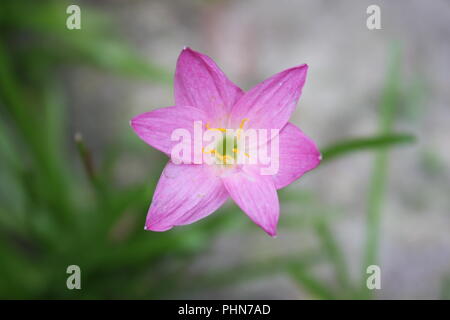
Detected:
left=130, top=107, right=207, bottom=162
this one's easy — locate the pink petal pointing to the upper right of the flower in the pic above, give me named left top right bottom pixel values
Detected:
left=231, top=64, right=308, bottom=130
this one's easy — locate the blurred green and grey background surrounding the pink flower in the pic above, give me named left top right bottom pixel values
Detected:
left=0, top=0, right=450, bottom=299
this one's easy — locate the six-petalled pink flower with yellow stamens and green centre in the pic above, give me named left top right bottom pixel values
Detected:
left=131, top=48, right=321, bottom=236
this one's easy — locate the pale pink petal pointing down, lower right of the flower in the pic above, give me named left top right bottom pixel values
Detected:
left=222, top=168, right=280, bottom=236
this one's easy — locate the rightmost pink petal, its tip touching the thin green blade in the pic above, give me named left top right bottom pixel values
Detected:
left=273, top=123, right=321, bottom=189
